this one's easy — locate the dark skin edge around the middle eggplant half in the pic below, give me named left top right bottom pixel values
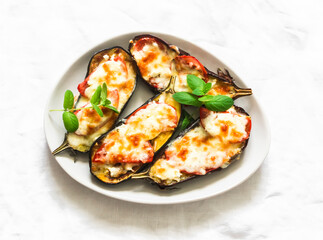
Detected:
left=89, top=88, right=183, bottom=185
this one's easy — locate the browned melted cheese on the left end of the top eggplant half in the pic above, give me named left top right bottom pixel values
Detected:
left=133, top=42, right=177, bottom=89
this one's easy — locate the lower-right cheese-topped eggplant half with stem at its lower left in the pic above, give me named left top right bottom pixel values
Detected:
left=133, top=106, right=251, bottom=188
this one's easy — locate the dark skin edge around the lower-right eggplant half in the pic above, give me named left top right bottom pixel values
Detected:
left=146, top=105, right=250, bottom=189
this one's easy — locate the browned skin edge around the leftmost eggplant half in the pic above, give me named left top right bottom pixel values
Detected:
left=66, top=46, right=138, bottom=152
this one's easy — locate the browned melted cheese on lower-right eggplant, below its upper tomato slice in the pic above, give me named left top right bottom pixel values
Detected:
left=151, top=126, right=246, bottom=182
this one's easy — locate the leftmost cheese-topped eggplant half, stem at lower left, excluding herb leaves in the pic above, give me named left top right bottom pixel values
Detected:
left=53, top=47, right=137, bottom=154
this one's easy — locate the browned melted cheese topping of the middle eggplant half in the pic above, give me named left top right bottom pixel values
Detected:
left=93, top=102, right=177, bottom=164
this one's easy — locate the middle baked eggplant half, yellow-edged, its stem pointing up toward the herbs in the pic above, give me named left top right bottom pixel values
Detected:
left=90, top=77, right=181, bottom=184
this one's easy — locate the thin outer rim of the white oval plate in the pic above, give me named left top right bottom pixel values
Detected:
left=43, top=31, right=271, bottom=205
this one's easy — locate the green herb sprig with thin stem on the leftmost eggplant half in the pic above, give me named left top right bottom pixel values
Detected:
left=50, top=83, right=119, bottom=132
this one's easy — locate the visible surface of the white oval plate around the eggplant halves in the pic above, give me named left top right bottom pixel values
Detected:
left=44, top=32, right=270, bottom=204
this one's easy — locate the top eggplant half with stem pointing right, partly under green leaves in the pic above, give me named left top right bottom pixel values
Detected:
left=129, top=35, right=252, bottom=99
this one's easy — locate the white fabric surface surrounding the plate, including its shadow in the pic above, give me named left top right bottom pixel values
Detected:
left=0, top=0, right=323, bottom=239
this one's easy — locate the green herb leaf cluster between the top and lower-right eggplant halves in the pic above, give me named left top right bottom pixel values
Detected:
left=173, top=74, right=233, bottom=112
